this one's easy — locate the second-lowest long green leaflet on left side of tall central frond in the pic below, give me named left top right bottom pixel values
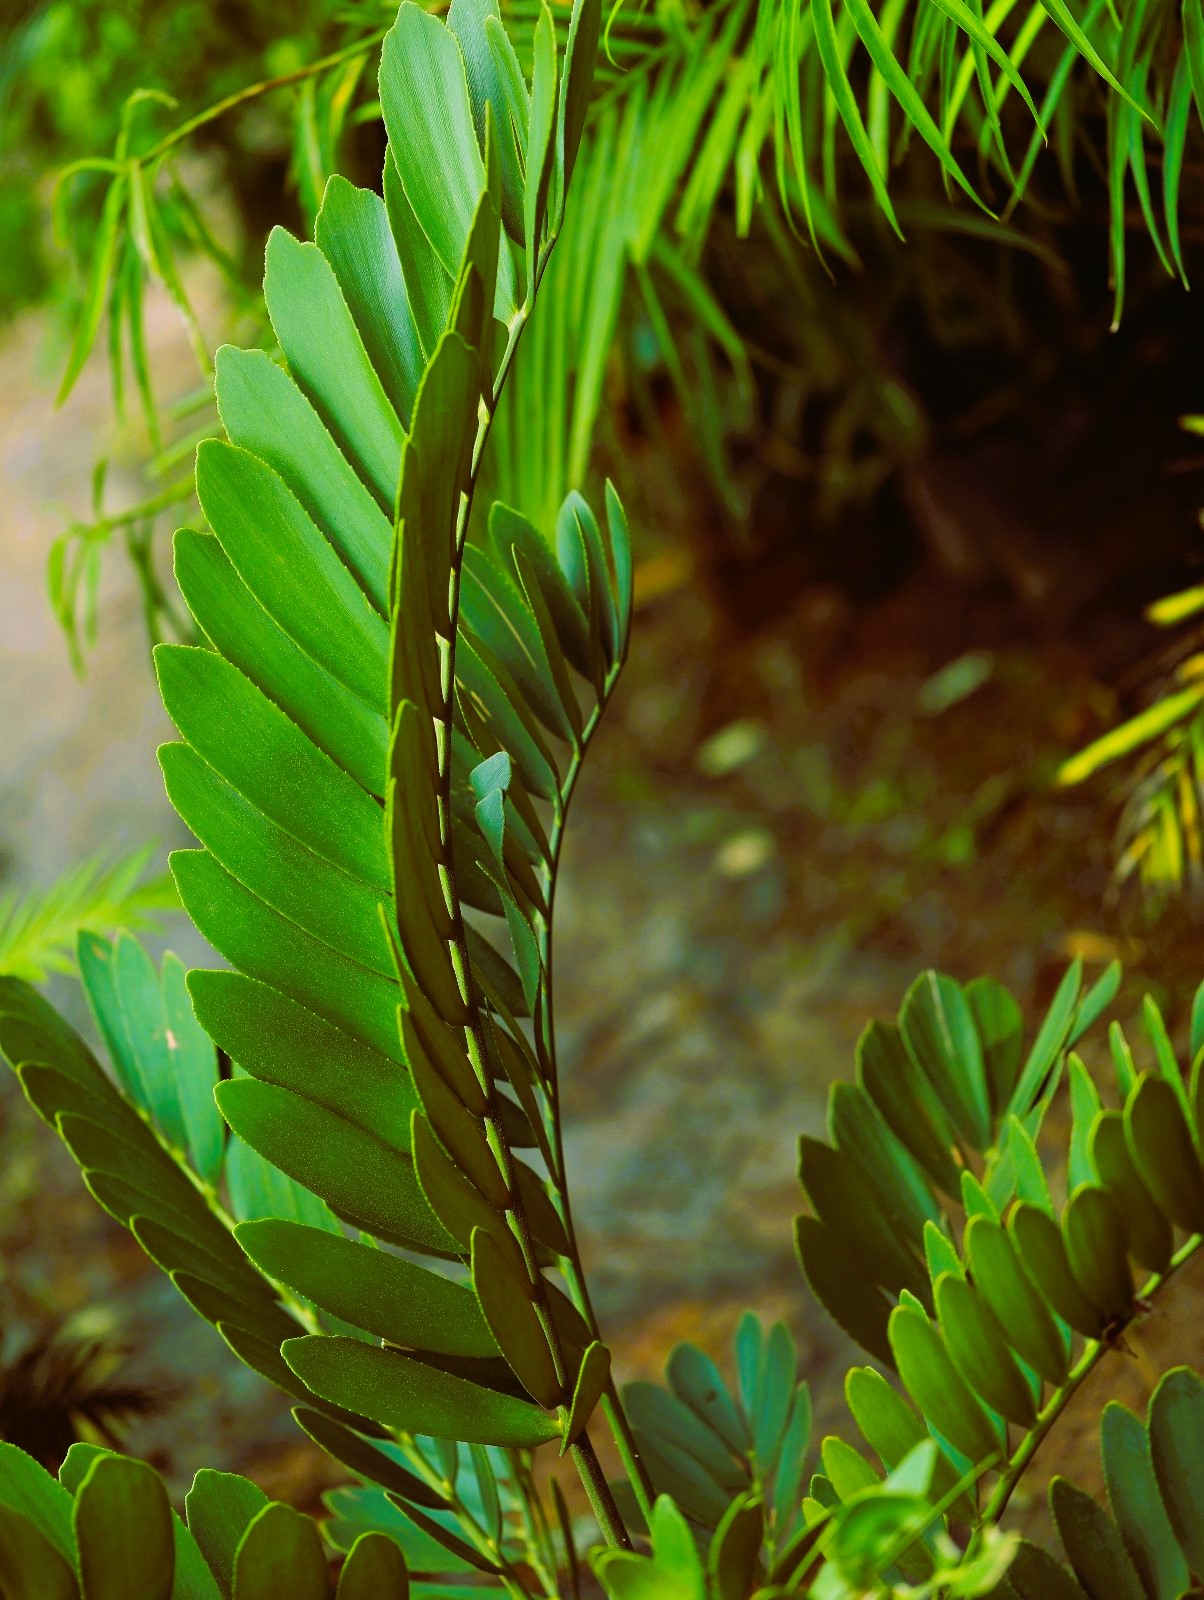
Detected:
left=234, top=1219, right=498, bottom=1355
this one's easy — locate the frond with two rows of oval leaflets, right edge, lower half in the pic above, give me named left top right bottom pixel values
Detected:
left=797, top=965, right=1204, bottom=1542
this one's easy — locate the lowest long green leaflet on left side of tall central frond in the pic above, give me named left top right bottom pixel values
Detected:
left=282, top=1336, right=559, bottom=1448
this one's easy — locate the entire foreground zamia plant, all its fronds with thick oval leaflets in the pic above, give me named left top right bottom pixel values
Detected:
left=0, top=0, right=1204, bottom=1600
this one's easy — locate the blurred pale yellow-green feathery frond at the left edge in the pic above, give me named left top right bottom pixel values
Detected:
left=0, top=845, right=179, bottom=984
